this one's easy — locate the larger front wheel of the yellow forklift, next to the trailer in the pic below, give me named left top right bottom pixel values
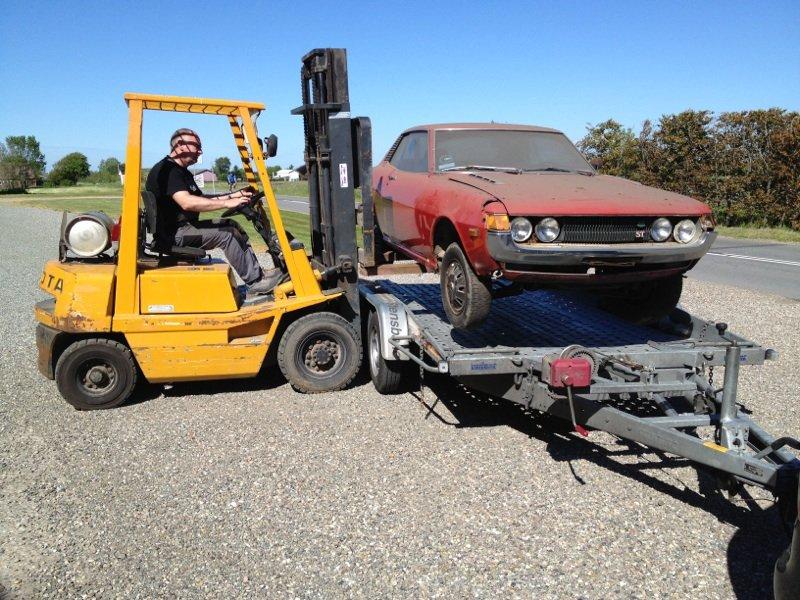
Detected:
left=278, top=312, right=361, bottom=394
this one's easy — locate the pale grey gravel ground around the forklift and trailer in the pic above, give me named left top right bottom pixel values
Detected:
left=0, top=205, right=800, bottom=598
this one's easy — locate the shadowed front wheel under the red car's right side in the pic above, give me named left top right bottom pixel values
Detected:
left=600, top=275, right=683, bottom=325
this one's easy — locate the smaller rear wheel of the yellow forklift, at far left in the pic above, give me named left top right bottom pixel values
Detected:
left=55, top=338, right=136, bottom=410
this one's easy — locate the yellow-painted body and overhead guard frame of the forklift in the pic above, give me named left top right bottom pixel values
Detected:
left=36, top=94, right=342, bottom=382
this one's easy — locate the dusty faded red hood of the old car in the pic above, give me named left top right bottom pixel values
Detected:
left=441, top=171, right=710, bottom=216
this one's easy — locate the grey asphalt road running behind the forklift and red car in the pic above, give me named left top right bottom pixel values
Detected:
left=278, top=196, right=800, bottom=300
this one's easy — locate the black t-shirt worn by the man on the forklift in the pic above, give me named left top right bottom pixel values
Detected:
left=145, top=156, right=203, bottom=246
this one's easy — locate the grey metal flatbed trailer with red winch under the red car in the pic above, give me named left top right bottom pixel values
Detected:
left=359, top=279, right=800, bottom=506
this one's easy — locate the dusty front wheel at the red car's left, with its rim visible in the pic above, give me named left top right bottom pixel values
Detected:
left=440, top=242, right=492, bottom=329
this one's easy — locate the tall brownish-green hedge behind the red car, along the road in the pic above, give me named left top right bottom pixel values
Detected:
left=577, top=108, right=800, bottom=230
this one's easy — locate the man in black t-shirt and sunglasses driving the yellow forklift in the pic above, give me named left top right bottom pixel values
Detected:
left=146, top=129, right=283, bottom=294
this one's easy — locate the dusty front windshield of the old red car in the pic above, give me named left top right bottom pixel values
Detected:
left=435, top=129, right=594, bottom=174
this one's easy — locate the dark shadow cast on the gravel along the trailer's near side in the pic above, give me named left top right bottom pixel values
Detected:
left=412, top=377, right=789, bottom=600
